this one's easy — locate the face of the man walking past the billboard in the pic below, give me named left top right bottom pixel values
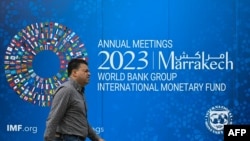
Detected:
left=74, top=64, right=90, bottom=86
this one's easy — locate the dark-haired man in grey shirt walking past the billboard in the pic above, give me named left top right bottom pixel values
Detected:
left=44, top=59, right=104, bottom=141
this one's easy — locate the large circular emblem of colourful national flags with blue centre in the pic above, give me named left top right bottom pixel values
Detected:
left=4, top=22, right=87, bottom=106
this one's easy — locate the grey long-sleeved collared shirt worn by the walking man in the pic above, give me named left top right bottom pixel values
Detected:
left=44, top=79, right=99, bottom=141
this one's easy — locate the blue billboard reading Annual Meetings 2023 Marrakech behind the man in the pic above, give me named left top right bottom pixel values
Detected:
left=0, top=0, right=250, bottom=141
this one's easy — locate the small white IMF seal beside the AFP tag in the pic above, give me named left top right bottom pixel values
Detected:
left=205, top=106, right=232, bottom=134
